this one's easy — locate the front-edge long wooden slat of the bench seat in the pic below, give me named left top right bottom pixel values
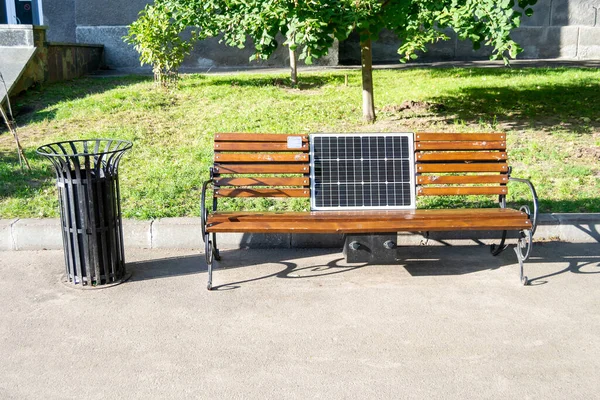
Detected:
left=206, top=218, right=531, bottom=233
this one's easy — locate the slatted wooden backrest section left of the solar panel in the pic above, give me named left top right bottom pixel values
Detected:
left=213, top=133, right=310, bottom=197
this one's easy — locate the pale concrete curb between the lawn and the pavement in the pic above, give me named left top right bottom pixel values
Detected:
left=0, top=213, right=600, bottom=251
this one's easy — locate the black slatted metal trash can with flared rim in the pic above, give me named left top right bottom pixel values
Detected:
left=37, top=139, right=133, bottom=287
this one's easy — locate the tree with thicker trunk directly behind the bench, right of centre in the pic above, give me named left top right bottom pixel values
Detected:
left=355, top=0, right=537, bottom=122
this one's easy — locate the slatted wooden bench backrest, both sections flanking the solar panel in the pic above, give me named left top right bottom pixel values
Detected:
left=213, top=133, right=508, bottom=203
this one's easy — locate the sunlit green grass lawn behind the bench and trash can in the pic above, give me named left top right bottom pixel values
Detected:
left=0, top=68, right=600, bottom=219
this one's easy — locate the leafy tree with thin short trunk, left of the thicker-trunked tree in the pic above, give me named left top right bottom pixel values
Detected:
left=162, top=0, right=353, bottom=84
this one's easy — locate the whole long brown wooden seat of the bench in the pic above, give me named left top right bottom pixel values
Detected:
left=206, top=208, right=531, bottom=233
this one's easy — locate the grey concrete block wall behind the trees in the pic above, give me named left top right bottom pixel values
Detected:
left=44, top=0, right=600, bottom=70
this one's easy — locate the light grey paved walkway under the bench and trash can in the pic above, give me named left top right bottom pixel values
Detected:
left=0, top=243, right=600, bottom=400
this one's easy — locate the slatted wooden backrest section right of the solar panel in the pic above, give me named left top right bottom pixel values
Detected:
left=415, top=133, right=508, bottom=196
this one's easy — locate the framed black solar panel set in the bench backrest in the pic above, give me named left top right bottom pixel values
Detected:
left=310, top=133, right=415, bottom=210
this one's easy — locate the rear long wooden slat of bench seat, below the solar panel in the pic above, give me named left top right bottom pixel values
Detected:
left=208, top=208, right=527, bottom=222
